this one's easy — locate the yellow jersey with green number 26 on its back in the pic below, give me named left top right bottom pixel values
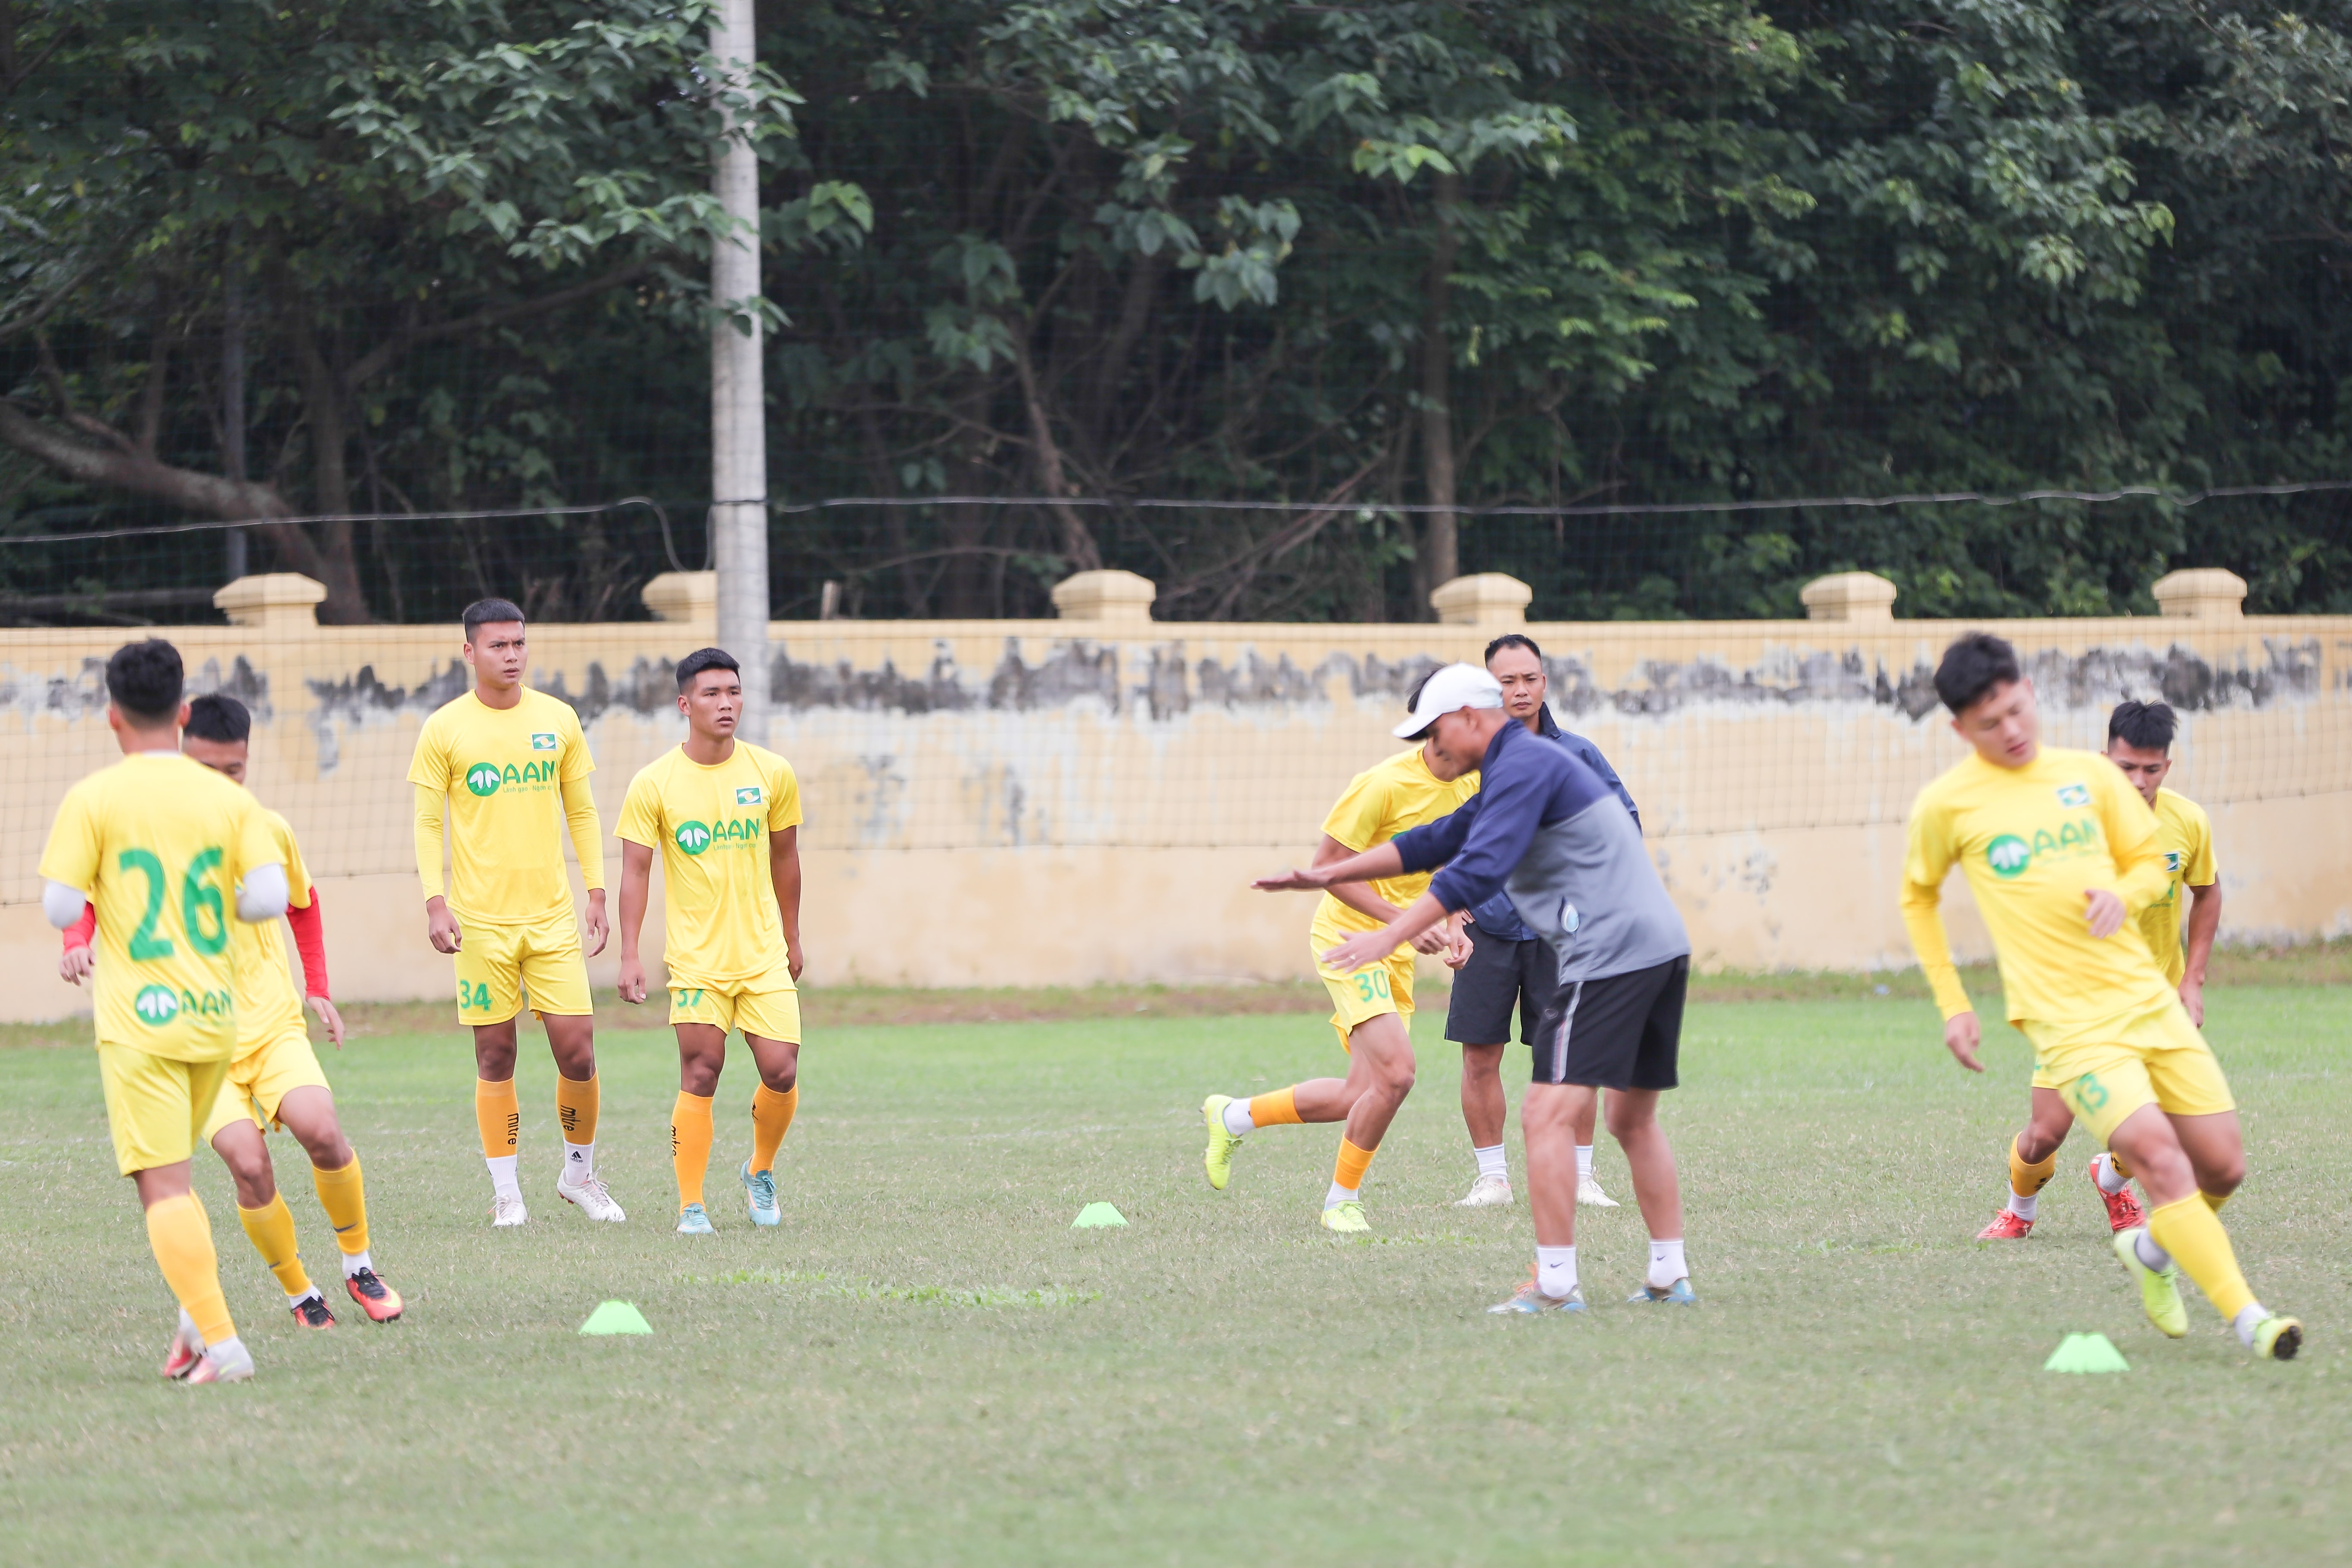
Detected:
left=40, top=752, right=285, bottom=1062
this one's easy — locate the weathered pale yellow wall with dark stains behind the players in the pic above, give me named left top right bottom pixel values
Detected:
left=0, top=618, right=2352, bottom=1018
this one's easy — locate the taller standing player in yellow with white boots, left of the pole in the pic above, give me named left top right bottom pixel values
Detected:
left=409, top=599, right=628, bottom=1225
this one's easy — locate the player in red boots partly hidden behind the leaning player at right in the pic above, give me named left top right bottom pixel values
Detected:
left=1976, top=703, right=2220, bottom=1241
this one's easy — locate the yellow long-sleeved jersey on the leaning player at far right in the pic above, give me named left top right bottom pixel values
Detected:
left=1903, top=748, right=2173, bottom=1030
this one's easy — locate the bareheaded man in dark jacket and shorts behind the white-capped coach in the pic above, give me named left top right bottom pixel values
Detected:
left=1447, top=632, right=1642, bottom=1208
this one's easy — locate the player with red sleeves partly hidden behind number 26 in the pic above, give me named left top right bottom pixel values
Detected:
left=59, top=693, right=400, bottom=1328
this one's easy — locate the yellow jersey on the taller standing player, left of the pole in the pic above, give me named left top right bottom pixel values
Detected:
left=409, top=686, right=604, bottom=926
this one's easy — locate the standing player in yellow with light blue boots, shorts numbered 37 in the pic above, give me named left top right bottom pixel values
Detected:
left=621, top=649, right=800, bottom=1236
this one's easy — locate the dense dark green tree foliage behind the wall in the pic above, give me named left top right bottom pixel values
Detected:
left=0, top=0, right=2352, bottom=618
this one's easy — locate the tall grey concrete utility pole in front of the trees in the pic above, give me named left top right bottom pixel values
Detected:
left=710, top=0, right=767, bottom=745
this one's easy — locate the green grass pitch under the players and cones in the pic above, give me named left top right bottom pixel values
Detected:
left=0, top=987, right=2352, bottom=1568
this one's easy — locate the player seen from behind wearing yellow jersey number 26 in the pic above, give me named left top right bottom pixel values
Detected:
left=40, top=640, right=287, bottom=1382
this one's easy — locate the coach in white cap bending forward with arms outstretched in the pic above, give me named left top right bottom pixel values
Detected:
left=1256, top=665, right=1698, bottom=1312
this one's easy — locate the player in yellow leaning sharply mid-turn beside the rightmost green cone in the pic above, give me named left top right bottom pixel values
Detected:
left=1903, top=632, right=2302, bottom=1361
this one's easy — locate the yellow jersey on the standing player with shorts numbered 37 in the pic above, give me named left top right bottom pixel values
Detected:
left=616, top=741, right=800, bottom=985
